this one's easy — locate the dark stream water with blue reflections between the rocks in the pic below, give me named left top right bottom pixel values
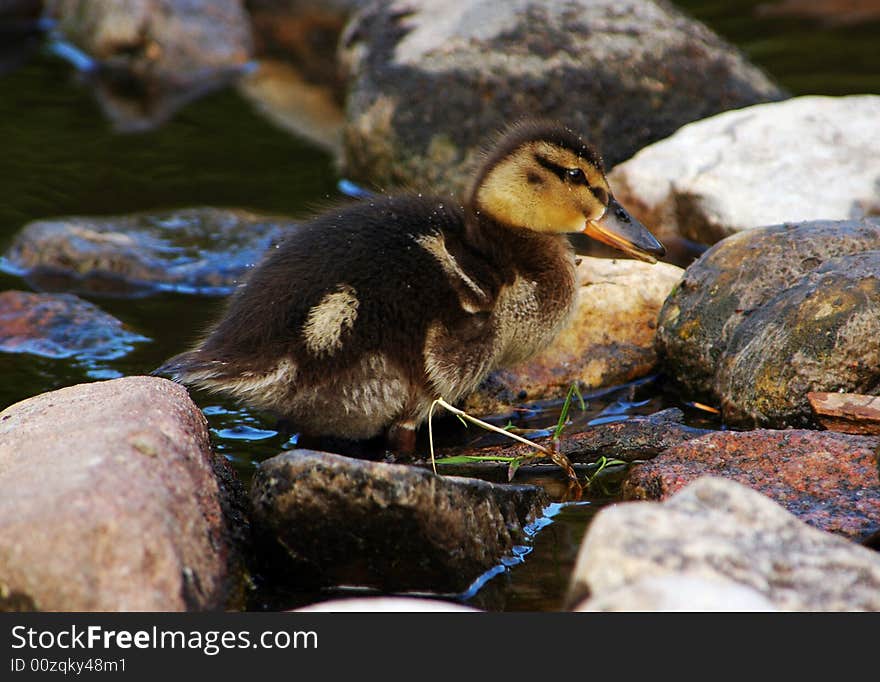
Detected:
left=0, top=1, right=880, bottom=610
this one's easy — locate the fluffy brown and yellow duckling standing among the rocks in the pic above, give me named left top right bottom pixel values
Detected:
left=155, top=122, right=664, bottom=454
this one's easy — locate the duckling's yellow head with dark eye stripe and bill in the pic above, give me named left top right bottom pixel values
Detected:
left=470, top=122, right=666, bottom=263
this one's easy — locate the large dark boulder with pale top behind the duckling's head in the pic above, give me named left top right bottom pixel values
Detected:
left=340, top=0, right=783, bottom=192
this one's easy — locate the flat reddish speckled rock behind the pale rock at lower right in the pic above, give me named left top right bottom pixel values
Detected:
left=622, top=430, right=880, bottom=542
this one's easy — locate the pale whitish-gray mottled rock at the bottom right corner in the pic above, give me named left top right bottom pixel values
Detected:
left=569, top=477, right=880, bottom=611
